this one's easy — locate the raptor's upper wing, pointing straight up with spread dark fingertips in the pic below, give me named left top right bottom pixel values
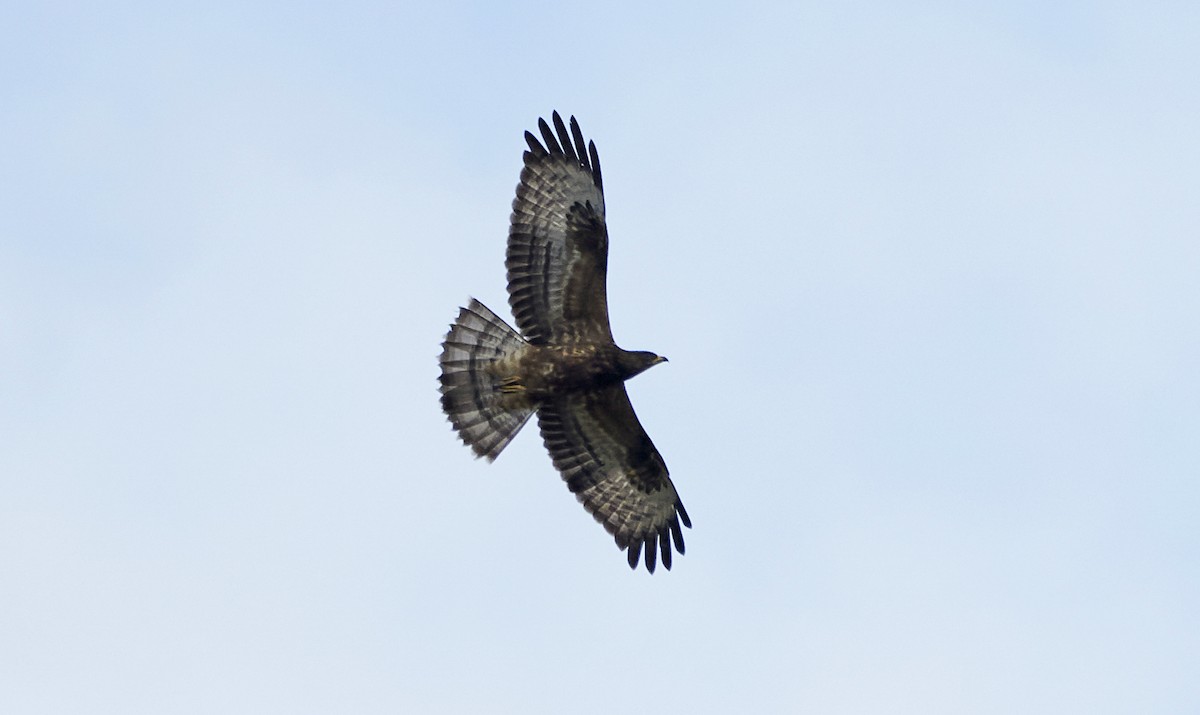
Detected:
left=505, top=112, right=612, bottom=346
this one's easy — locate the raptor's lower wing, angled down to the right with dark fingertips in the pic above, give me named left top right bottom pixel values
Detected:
left=538, top=384, right=691, bottom=573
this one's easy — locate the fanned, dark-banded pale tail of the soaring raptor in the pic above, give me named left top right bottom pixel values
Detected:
left=439, top=299, right=533, bottom=462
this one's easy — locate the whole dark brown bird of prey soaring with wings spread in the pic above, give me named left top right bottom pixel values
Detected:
left=440, top=112, right=691, bottom=573
